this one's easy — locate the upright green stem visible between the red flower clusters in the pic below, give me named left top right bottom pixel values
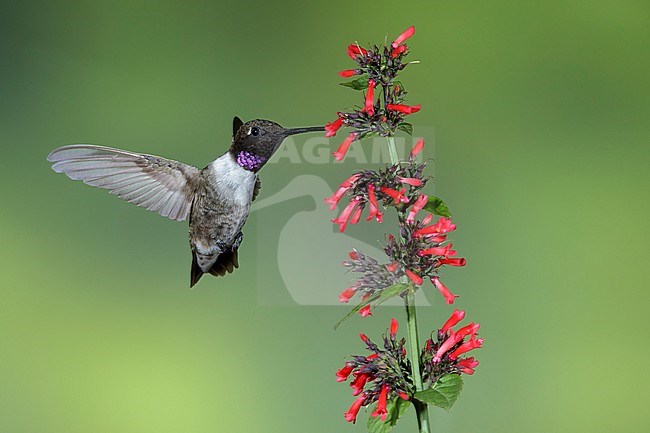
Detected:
left=386, top=136, right=431, bottom=433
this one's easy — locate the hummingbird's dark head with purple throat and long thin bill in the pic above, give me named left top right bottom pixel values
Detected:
left=230, top=117, right=325, bottom=172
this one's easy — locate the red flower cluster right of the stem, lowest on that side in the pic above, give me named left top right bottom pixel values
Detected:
left=422, top=310, right=483, bottom=383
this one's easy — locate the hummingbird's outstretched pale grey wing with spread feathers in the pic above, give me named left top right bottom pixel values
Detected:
left=47, top=144, right=199, bottom=221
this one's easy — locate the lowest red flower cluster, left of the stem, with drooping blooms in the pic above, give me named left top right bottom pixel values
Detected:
left=336, top=319, right=413, bottom=423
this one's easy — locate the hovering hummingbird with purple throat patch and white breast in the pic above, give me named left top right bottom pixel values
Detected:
left=47, top=117, right=325, bottom=287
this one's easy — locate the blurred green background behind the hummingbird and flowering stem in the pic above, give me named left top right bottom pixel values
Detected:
left=0, top=0, right=650, bottom=433
